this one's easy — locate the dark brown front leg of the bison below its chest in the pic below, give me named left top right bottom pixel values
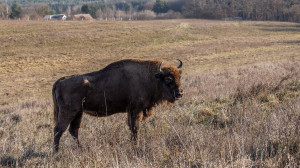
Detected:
left=128, top=111, right=143, bottom=142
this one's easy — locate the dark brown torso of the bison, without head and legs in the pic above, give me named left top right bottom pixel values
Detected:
left=52, top=60, right=163, bottom=116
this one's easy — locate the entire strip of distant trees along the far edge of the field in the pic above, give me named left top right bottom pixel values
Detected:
left=0, top=0, right=300, bottom=22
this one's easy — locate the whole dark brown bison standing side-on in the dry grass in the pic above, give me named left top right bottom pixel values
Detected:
left=52, top=59, right=183, bottom=151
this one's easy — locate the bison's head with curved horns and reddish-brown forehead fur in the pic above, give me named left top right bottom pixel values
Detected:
left=155, top=60, right=183, bottom=102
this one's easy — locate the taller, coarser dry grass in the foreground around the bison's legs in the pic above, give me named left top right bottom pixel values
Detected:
left=0, top=62, right=300, bottom=167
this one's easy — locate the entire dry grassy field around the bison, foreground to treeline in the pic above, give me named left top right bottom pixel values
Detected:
left=0, top=20, right=300, bottom=168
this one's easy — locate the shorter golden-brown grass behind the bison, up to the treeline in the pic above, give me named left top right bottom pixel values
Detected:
left=0, top=20, right=300, bottom=104
